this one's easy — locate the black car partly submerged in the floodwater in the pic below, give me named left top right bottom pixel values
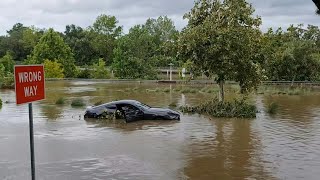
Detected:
left=84, top=100, right=180, bottom=122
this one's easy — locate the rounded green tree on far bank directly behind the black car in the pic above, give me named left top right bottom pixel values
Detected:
left=112, top=25, right=156, bottom=79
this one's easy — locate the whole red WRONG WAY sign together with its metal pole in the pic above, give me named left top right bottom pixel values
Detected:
left=14, top=65, right=45, bottom=180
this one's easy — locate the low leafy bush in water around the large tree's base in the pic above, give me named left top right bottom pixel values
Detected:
left=180, top=98, right=257, bottom=118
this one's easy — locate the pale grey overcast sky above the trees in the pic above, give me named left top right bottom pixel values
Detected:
left=0, top=0, right=320, bottom=35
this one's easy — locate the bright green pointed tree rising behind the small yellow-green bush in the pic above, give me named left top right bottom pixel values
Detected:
left=27, top=29, right=76, bottom=78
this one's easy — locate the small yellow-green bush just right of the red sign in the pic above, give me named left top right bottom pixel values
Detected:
left=44, top=59, right=64, bottom=78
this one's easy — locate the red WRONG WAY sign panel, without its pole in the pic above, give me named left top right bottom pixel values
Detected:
left=14, top=65, right=45, bottom=104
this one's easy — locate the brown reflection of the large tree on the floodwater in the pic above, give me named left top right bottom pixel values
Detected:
left=184, top=116, right=272, bottom=180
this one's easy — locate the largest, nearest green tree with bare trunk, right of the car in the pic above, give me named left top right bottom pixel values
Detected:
left=179, top=0, right=262, bottom=101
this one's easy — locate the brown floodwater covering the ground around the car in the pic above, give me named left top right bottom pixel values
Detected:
left=0, top=81, right=320, bottom=180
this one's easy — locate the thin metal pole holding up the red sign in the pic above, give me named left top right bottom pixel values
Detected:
left=29, top=103, right=36, bottom=180
